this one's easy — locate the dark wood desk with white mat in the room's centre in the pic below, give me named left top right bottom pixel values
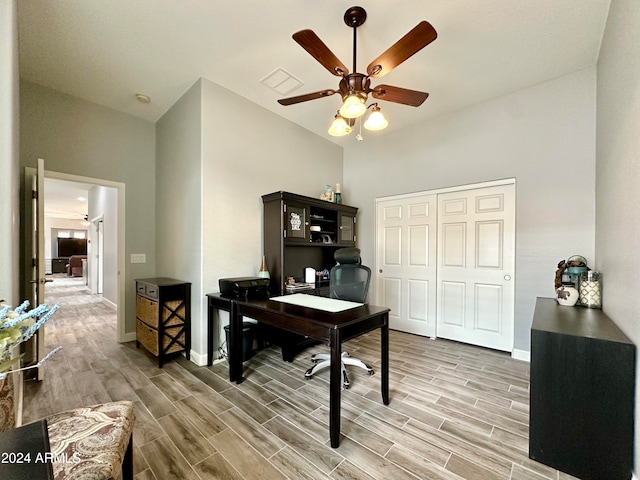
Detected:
left=207, top=294, right=389, bottom=448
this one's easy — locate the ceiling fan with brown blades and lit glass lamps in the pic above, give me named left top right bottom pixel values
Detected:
left=278, top=7, right=438, bottom=136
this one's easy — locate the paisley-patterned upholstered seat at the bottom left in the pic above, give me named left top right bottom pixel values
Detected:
left=47, top=401, right=135, bottom=480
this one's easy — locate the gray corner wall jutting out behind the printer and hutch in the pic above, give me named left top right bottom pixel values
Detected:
left=156, top=79, right=342, bottom=357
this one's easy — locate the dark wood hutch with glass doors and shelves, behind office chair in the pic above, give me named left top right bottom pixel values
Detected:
left=262, top=192, right=358, bottom=294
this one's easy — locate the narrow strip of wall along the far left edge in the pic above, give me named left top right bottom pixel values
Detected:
left=0, top=0, right=21, bottom=306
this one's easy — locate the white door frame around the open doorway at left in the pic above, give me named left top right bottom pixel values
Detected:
left=44, top=170, right=126, bottom=343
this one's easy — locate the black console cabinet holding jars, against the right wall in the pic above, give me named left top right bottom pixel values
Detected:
left=529, top=298, right=636, bottom=480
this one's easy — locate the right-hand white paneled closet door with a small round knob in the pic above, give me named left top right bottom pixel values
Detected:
left=437, top=184, right=515, bottom=351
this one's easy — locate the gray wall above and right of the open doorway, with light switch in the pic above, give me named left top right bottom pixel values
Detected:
left=20, top=82, right=155, bottom=332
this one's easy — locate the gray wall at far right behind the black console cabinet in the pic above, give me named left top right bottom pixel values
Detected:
left=596, top=0, right=640, bottom=466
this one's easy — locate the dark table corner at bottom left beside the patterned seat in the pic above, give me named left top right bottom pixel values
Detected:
left=0, top=420, right=53, bottom=480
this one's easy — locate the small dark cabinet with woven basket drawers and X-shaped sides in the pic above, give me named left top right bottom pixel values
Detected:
left=136, top=278, right=191, bottom=368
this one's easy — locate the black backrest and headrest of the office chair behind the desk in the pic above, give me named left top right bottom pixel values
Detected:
left=329, top=247, right=371, bottom=303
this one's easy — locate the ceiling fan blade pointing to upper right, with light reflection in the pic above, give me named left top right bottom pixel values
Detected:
left=367, top=20, right=438, bottom=78
